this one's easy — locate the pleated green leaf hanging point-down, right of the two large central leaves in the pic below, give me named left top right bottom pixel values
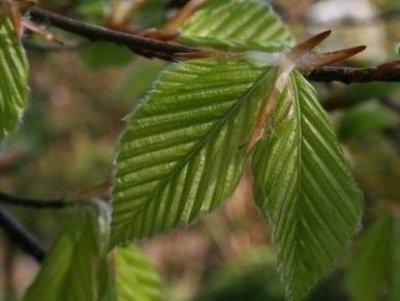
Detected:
left=253, top=72, right=361, bottom=300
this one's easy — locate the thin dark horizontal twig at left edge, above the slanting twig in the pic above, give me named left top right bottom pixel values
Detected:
left=0, top=192, right=71, bottom=209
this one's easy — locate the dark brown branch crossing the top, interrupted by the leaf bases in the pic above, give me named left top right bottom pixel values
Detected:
left=30, top=8, right=400, bottom=83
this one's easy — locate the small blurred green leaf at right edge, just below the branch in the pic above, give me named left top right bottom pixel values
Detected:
left=339, top=103, right=398, bottom=139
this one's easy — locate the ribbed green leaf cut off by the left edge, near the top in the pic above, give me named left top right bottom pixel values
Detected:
left=0, top=9, right=28, bottom=140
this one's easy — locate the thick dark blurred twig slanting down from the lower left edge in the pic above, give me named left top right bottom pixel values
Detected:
left=0, top=205, right=46, bottom=262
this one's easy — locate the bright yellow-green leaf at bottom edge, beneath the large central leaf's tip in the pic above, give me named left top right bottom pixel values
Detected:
left=114, top=246, right=162, bottom=301
